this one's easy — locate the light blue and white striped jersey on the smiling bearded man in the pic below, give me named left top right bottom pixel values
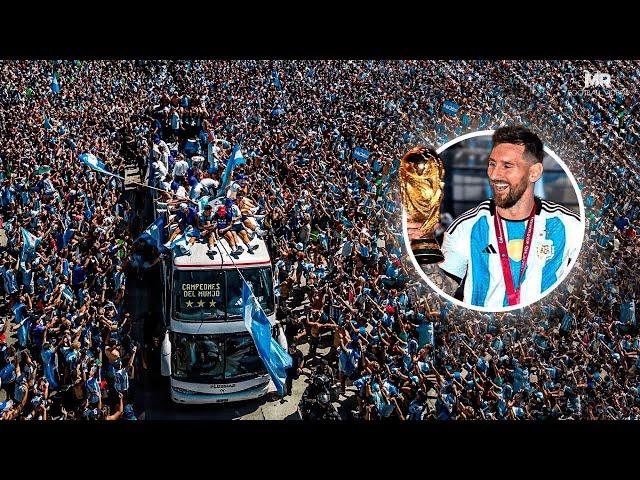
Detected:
left=439, top=197, right=584, bottom=308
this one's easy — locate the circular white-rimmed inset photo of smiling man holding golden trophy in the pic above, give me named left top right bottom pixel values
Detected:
left=399, top=125, right=585, bottom=312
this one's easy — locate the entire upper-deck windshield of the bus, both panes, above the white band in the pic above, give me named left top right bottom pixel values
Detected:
left=173, top=267, right=274, bottom=321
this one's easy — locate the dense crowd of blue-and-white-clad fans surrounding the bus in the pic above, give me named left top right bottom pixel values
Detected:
left=0, top=61, right=640, bottom=419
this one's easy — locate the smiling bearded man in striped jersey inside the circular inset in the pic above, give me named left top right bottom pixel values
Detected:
left=439, top=126, right=583, bottom=309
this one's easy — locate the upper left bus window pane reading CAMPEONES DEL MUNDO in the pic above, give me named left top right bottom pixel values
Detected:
left=173, top=270, right=225, bottom=321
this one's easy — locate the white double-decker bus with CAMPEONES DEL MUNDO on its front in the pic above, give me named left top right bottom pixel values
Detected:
left=158, top=227, right=286, bottom=404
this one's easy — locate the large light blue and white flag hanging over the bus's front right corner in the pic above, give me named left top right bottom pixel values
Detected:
left=242, top=281, right=293, bottom=395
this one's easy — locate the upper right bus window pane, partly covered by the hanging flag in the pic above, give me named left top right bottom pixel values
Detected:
left=227, top=267, right=274, bottom=316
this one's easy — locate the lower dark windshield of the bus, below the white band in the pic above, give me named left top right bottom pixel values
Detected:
left=172, top=333, right=267, bottom=383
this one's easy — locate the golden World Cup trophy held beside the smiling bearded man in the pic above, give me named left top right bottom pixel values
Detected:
left=399, top=146, right=444, bottom=264
